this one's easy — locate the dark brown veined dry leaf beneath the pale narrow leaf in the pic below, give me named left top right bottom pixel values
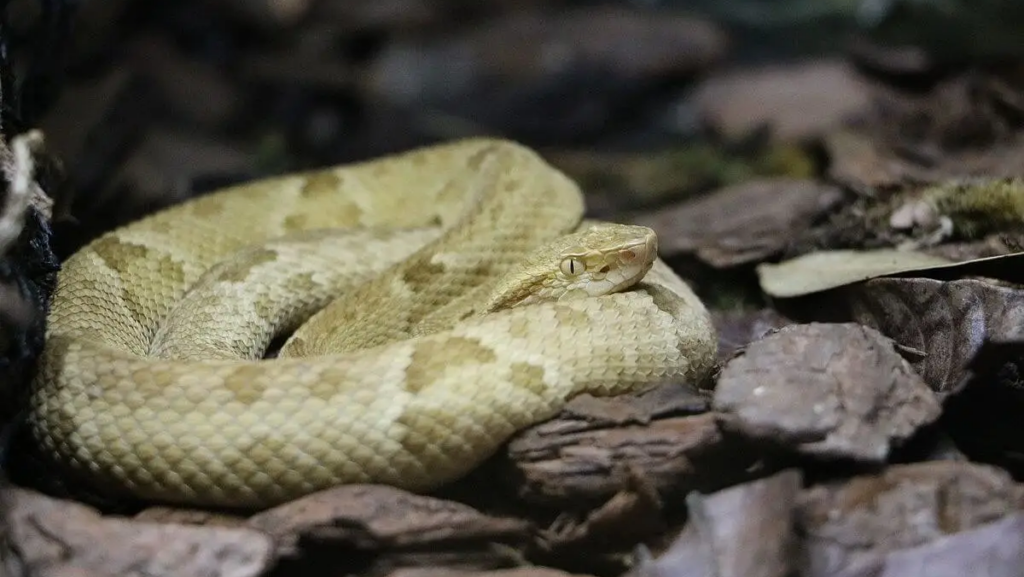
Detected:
left=844, top=279, right=1024, bottom=395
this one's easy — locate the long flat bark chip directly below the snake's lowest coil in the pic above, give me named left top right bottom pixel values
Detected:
left=247, top=485, right=529, bottom=553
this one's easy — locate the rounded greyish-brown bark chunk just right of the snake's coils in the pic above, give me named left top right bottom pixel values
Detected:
left=713, top=323, right=940, bottom=461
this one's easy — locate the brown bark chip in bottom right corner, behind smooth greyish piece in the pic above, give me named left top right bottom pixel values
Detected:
left=798, top=461, right=1024, bottom=577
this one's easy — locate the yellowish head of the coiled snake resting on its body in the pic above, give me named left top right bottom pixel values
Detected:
left=487, top=222, right=657, bottom=311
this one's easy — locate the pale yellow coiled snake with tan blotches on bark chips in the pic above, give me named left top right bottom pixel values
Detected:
left=27, top=136, right=717, bottom=509
